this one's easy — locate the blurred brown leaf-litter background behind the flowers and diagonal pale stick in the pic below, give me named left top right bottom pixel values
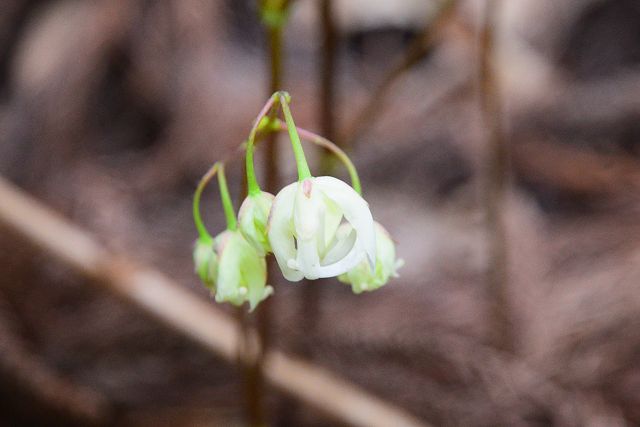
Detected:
left=0, top=0, right=640, bottom=426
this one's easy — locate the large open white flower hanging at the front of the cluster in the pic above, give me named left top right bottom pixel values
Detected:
left=268, top=176, right=376, bottom=282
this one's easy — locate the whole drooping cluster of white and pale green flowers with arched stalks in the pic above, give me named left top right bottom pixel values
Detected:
left=193, top=91, right=403, bottom=310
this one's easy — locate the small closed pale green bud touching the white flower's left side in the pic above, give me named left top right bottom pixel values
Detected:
left=238, top=191, right=274, bottom=256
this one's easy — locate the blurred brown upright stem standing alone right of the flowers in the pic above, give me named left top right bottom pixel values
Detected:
left=479, top=0, right=514, bottom=351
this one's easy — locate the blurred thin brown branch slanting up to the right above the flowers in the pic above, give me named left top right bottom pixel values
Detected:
left=339, top=0, right=458, bottom=147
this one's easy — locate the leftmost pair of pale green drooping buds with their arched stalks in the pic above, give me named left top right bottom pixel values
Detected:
left=193, top=163, right=273, bottom=310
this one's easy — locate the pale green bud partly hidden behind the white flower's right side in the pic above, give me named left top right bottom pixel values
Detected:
left=338, top=222, right=404, bottom=294
